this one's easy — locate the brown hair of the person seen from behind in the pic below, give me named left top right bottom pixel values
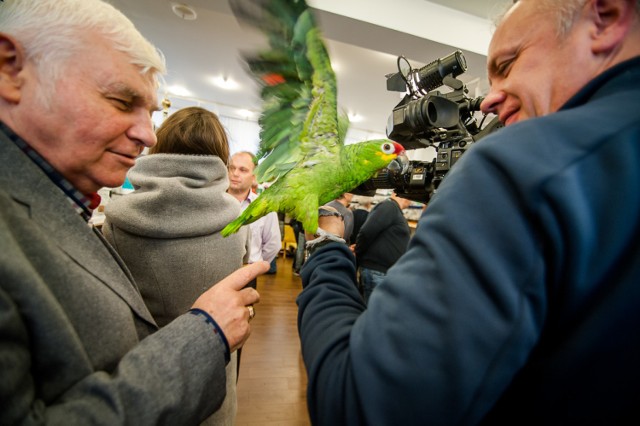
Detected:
left=149, top=107, right=229, bottom=164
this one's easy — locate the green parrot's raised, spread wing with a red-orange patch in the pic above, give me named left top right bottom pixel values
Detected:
left=229, top=0, right=348, bottom=182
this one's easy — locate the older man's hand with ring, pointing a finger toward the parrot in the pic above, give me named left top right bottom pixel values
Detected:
left=192, top=262, right=269, bottom=352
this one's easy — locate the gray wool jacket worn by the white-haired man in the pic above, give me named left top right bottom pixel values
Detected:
left=0, top=125, right=225, bottom=425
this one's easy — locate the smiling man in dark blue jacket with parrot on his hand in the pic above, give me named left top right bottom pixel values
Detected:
left=298, top=0, right=640, bottom=425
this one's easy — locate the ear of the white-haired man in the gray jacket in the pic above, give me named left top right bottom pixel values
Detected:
left=0, top=32, right=24, bottom=103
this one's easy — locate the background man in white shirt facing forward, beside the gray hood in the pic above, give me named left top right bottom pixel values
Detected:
left=227, top=151, right=282, bottom=288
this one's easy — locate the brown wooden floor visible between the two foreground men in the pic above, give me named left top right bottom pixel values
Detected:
left=236, top=255, right=311, bottom=426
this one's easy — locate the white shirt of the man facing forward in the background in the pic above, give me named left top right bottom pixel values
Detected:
left=240, top=191, right=282, bottom=263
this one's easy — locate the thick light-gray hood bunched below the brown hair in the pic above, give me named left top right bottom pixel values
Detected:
left=105, top=154, right=240, bottom=238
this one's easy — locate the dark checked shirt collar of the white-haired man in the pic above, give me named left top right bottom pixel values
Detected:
left=0, top=121, right=95, bottom=221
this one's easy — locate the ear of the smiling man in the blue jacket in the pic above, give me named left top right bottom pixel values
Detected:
left=589, top=0, right=636, bottom=54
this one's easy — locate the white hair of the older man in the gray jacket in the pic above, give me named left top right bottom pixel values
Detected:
left=0, top=0, right=166, bottom=100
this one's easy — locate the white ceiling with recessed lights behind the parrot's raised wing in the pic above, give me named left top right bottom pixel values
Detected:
left=109, top=0, right=511, bottom=133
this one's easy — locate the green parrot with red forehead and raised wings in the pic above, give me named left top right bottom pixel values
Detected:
left=222, top=0, right=404, bottom=236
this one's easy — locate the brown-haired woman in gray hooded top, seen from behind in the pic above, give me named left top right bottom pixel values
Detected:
left=102, top=107, right=248, bottom=425
